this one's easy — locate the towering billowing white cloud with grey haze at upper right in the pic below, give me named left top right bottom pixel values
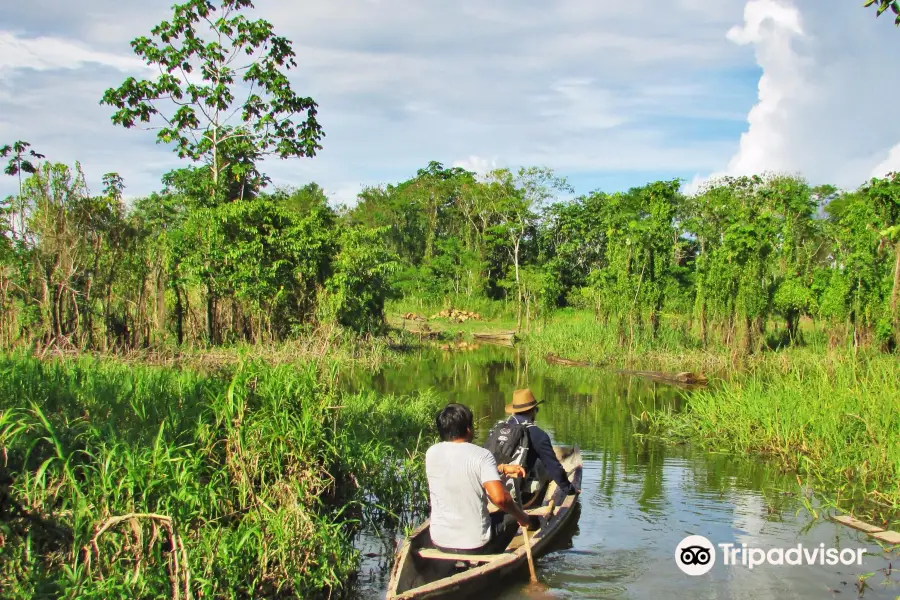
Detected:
left=686, top=0, right=900, bottom=192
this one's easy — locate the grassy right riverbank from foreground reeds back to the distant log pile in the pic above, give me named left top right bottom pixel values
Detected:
left=388, top=307, right=900, bottom=524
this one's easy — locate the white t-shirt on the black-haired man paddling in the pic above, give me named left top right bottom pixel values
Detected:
left=425, top=442, right=500, bottom=550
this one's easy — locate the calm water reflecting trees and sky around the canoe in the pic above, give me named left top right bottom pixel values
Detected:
left=342, top=346, right=900, bottom=600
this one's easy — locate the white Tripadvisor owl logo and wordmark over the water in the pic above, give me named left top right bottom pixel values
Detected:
left=675, top=535, right=866, bottom=575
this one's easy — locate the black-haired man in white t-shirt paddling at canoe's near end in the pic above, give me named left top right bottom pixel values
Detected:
left=425, top=404, right=540, bottom=554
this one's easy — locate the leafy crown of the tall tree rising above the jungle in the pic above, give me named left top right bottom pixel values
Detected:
left=101, top=0, right=323, bottom=204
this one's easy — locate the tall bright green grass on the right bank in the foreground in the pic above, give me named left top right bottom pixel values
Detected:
left=665, top=352, right=900, bottom=518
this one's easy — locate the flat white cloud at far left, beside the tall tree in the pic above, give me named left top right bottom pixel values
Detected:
left=0, top=31, right=149, bottom=73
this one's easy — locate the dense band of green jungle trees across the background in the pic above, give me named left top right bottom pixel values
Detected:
left=0, top=152, right=900, bottom=352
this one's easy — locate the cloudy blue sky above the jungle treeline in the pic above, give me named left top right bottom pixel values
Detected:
left=0, top=0, right=900, bottom=204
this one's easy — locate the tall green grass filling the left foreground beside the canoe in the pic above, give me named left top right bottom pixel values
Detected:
left=0, top=355, right=436, bottom=598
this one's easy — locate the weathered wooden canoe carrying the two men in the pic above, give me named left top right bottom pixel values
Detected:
left=386, top=446, right=582, bottom=600
